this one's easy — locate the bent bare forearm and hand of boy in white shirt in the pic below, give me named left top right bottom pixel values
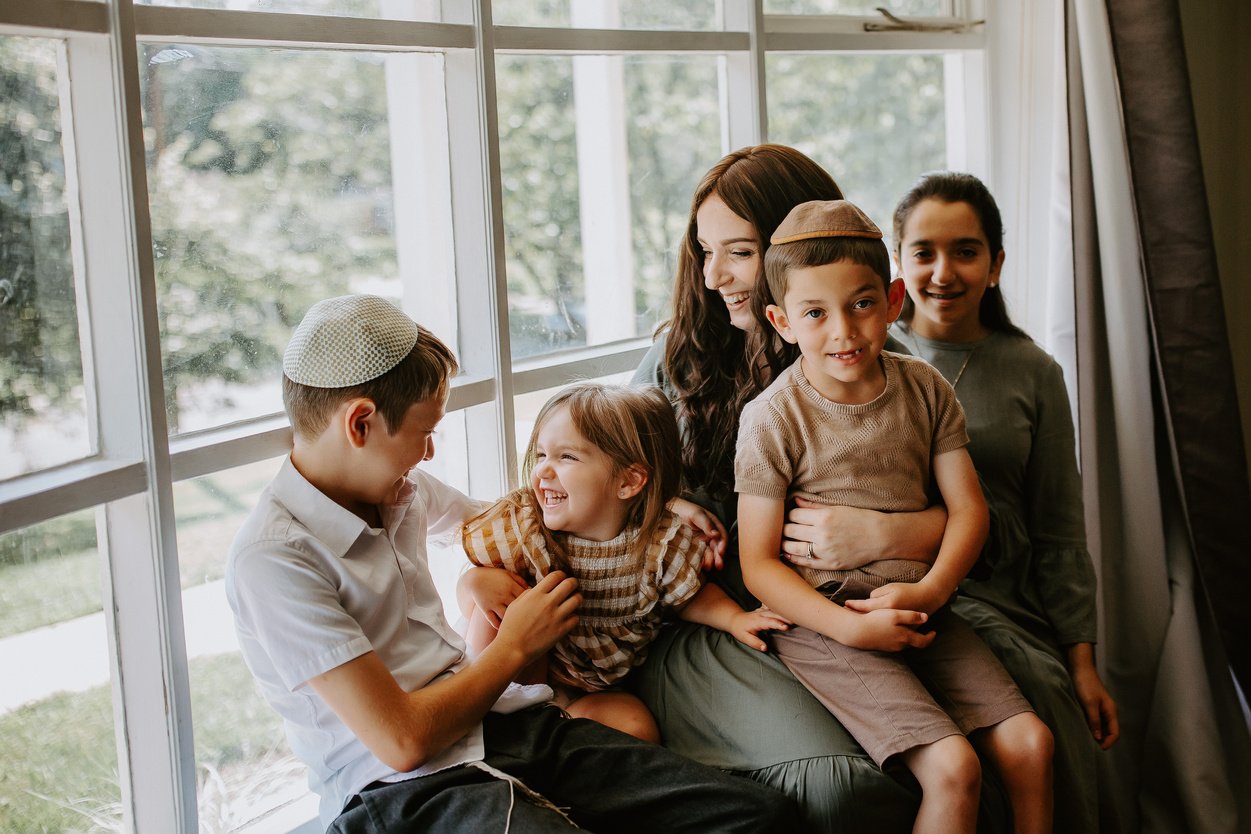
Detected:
left=309, top=571, right=582, bottom=773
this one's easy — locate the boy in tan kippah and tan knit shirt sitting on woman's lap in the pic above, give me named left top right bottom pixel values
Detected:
left=734, top=200, right=1052, bottom=834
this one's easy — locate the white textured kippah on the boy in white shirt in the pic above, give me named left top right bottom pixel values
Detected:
left=283, top=295, right=418, bottom=388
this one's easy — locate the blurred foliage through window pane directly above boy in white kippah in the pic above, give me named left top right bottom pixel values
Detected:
left=144, top=48, right=395, bottom=428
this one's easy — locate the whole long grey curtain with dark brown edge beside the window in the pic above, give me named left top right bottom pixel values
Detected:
left=1066, top=0, right=1251, bottom=833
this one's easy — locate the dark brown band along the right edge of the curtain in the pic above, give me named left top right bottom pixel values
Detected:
left=1107, top=0, right=1251, bottom=691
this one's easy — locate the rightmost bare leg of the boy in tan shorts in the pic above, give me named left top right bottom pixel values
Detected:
left=972, top=713, right=1055, bottom=834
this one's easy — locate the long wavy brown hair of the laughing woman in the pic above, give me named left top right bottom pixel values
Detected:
left=662, top=145, right=843, bottom=498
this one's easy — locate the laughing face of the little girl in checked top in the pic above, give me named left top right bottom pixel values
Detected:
left=530, top=406, right=642, bottom=541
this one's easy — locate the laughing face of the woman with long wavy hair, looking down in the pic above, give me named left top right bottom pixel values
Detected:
left=696, top=194, right=761, bottom=330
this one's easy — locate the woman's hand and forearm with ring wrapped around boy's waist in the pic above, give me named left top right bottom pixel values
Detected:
left=782, top=498, right=947, bottom=570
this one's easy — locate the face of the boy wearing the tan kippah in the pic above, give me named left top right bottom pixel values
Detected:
left=766, top=261, right=903, bottom=405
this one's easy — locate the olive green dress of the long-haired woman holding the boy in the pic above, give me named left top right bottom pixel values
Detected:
left=628, top=336, right=1010, bottom=834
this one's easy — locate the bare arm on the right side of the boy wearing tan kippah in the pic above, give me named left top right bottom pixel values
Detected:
left=847, top=448, right=991, bottom=614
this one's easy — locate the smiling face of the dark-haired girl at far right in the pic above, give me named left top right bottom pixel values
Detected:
left=899, top=198, right=1003, bottom=341
